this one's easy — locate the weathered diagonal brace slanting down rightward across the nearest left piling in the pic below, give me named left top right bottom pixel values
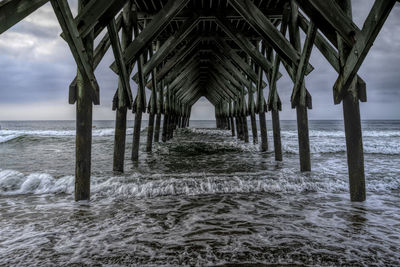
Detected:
left=51, top=0, right=100, bottom=105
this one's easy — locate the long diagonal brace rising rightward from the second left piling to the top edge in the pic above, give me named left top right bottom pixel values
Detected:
left=111, top=0, right=189, bottom=72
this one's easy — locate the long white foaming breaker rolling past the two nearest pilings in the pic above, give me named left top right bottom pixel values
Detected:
left=0, top=169, right=400, bottom=199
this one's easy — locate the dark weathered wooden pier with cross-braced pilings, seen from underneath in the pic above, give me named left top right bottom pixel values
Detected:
left=0, top=0, right=397, bottom=201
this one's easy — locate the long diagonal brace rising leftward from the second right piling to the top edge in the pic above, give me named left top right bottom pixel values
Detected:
left=230, top=0, right=313, bottom=73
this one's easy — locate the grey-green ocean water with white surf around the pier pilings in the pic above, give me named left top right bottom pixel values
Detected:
left=0, top=121, right=400, bottom=266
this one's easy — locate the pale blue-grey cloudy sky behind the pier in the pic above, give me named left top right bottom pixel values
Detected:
left=0, top=0, right=400, bottom=120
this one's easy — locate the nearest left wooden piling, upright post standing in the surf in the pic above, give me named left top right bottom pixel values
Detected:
left=75, top=0, right=94, bottom=201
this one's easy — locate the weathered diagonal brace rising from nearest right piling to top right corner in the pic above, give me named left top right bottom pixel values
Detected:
left=333, top=0, right=396, bottom=104
